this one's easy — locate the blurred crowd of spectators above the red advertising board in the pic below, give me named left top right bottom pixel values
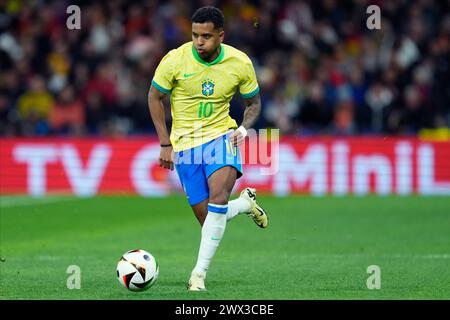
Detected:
left=0, top=0, right=450, bottom=136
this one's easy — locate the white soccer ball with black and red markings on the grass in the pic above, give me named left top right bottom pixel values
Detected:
left=117, top=249, right=159, bottom=291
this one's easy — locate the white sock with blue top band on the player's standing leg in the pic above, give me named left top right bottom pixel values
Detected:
left=193, top=203, right=228, bottom=274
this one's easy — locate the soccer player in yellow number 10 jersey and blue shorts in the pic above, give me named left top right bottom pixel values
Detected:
left=148, top=7, right=268, bottom=291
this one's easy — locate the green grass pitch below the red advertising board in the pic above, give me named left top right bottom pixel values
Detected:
left=0, top=196, right=450, bottom=300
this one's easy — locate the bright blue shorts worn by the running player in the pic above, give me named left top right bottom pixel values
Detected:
left=174, top=131, right=243, bottom=206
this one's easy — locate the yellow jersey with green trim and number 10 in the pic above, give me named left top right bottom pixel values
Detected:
left=152, top=41, right=259, bottom=152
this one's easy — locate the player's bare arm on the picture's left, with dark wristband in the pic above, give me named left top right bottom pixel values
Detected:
left=148, top=86, right=173, bottom=170
